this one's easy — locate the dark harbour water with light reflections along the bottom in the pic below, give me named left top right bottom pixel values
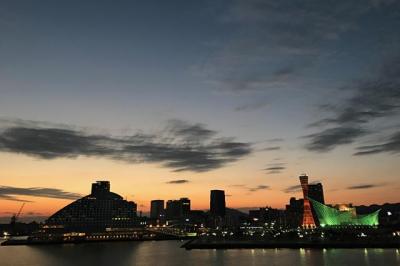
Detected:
left=0, top=241, right=400, bottom=266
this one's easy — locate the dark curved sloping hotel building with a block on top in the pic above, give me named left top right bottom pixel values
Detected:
left=45, top=181, right=137, bottom=232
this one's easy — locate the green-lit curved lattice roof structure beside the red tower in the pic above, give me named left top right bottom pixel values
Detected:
left=309, top=198, right=380, bottom=227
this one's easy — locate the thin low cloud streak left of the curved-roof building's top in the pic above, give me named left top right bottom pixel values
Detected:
left=0, top=186, right=82, bottom=202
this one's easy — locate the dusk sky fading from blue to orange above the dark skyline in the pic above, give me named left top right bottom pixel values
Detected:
left=0, top=0, right=400, bottom=221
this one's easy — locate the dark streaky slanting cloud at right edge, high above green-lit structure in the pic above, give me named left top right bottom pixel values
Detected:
left=306, top=56, right=400, bottom=152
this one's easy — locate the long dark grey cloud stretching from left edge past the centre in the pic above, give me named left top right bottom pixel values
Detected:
left=0, top=120, right=252, bottom=172
